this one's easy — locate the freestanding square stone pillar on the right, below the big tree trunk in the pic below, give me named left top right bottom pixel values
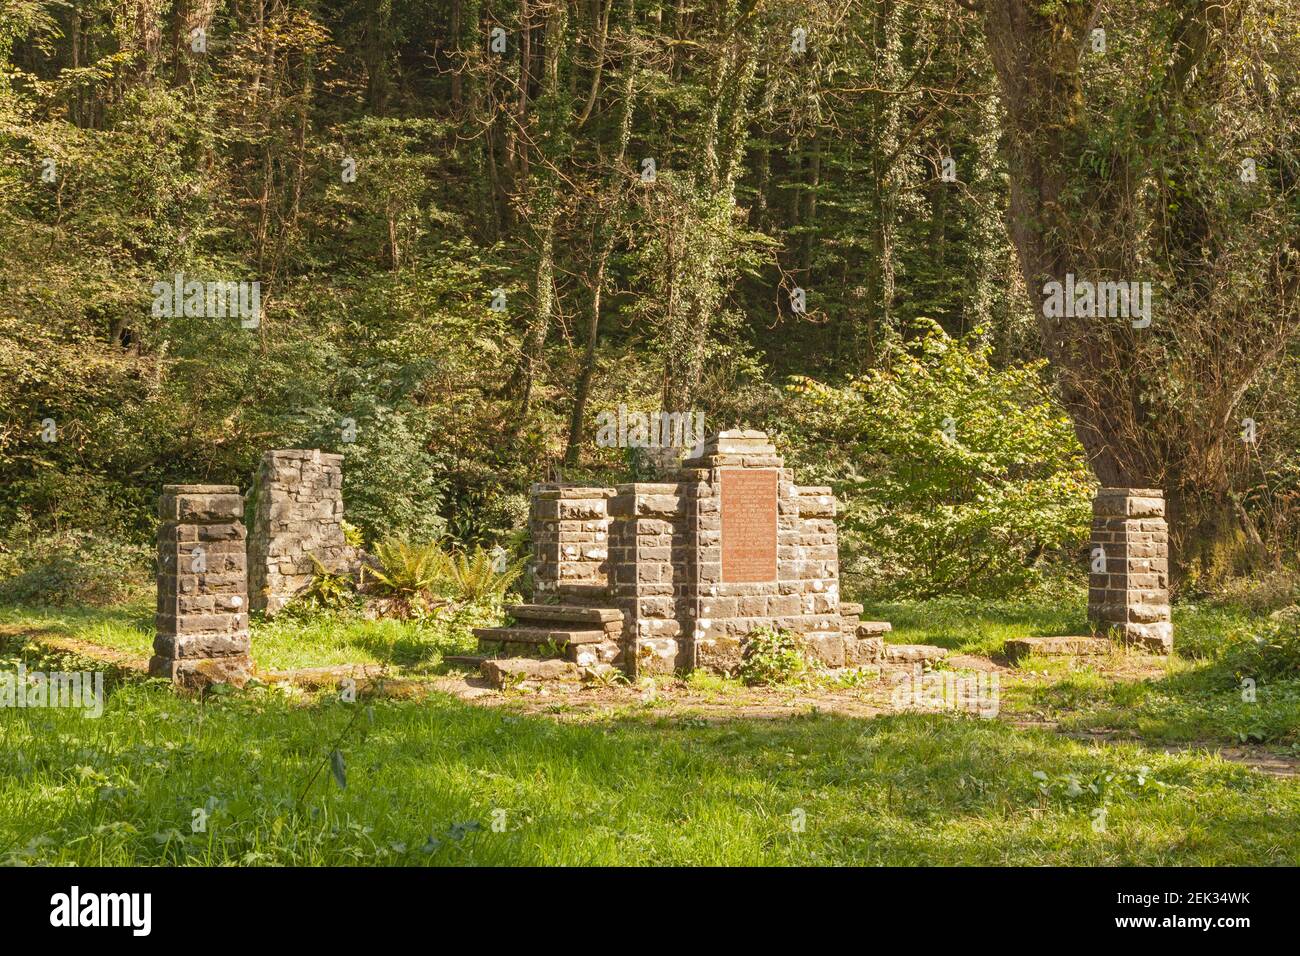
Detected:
left=1088, top=488, right=1174, bottom=654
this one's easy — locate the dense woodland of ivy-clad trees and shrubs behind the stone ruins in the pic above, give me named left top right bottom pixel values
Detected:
left=0, top=0, right=1300, bottom=598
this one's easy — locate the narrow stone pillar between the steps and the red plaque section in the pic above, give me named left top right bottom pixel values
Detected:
left=610, top=481, right=693, bottom=678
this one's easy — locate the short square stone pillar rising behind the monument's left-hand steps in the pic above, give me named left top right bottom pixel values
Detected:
left=529, top=483, right=614, bottom=600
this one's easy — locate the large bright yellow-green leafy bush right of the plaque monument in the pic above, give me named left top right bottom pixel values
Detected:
left=783, top=320, right=1095, bottom=597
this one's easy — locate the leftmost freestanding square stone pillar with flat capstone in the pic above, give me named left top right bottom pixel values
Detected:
left=150, top=485, right=252, bottom=687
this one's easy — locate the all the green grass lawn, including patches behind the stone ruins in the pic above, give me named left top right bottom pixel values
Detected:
left=0, top=590, right=1300, bottom=865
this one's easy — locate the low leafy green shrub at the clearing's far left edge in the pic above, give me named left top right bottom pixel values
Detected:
left=0, top=531, right=152, bottom=606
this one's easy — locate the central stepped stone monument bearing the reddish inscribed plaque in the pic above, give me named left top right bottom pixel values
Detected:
left=475, top=431, right=889, bottom=683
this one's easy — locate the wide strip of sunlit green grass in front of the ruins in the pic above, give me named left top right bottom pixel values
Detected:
left=0, top=683, right=1300, bottom=865
